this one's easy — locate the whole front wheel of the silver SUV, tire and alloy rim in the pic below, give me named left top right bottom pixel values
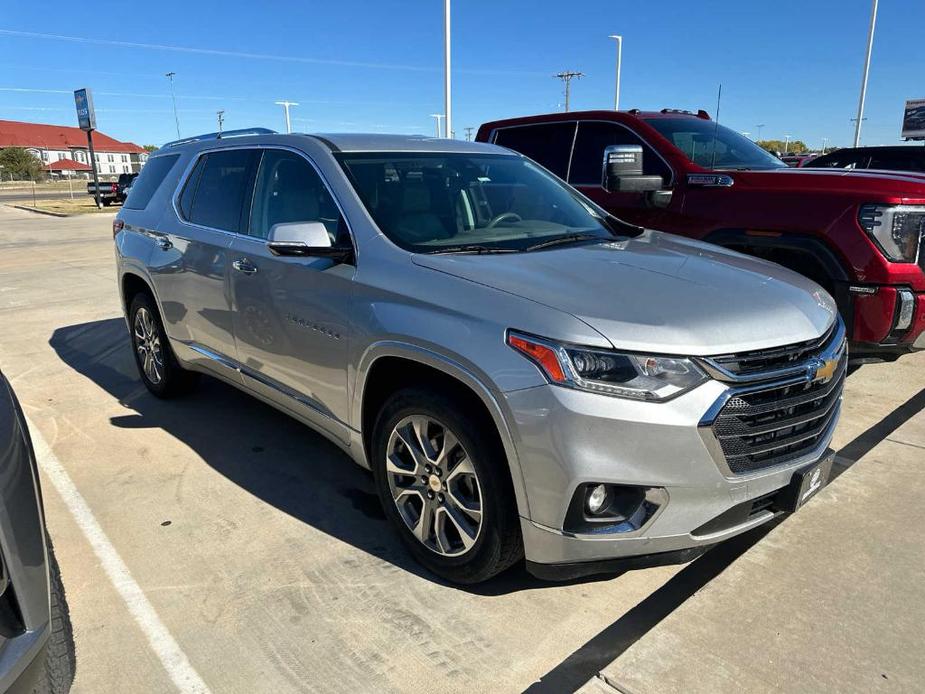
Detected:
left=370, top=388, right=523, bottom=584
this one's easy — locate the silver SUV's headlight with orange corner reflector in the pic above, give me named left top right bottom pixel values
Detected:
left=507, top=332, right=708, bottom=400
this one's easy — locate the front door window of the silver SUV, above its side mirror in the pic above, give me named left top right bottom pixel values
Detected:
left=247, top=149, right=345, bottom=243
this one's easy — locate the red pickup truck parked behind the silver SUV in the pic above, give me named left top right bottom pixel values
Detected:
left=477, top=109, right=925, bottom=363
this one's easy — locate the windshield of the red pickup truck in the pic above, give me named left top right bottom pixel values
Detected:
left=646, top=118, right=787, bottom=171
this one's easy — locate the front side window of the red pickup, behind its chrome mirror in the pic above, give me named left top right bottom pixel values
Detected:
left=569, top=121, right=672, bottom=185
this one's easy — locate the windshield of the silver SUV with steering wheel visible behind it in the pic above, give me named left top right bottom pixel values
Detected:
left=339, top=152, right=614, bottom=253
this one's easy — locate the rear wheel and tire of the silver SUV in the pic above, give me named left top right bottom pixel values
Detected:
left=129, top=292, right=199, bottom=398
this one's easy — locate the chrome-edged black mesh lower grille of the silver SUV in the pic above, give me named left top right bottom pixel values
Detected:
left=712, top=351, right=848, bottom=474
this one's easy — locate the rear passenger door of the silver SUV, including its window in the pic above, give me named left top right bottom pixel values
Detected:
left=149, top=148, right=258, bottom=379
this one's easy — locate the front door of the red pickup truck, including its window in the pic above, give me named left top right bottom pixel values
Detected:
left=568, top=121, right=681, bottom=231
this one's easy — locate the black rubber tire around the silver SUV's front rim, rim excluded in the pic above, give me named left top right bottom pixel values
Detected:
left=369, top=389, right=519, bottom=583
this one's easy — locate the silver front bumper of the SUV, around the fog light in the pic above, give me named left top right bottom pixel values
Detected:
left=506, top=370, right=840, bottom=577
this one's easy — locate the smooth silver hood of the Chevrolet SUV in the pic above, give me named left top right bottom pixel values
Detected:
left=413, top=230, right=836, bottom=356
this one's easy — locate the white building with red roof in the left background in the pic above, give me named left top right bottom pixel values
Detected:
left=0, top=120, right=148, bottom=176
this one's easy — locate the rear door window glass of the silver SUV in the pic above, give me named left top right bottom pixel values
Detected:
left=180, top=149, right=258, bottom=232
